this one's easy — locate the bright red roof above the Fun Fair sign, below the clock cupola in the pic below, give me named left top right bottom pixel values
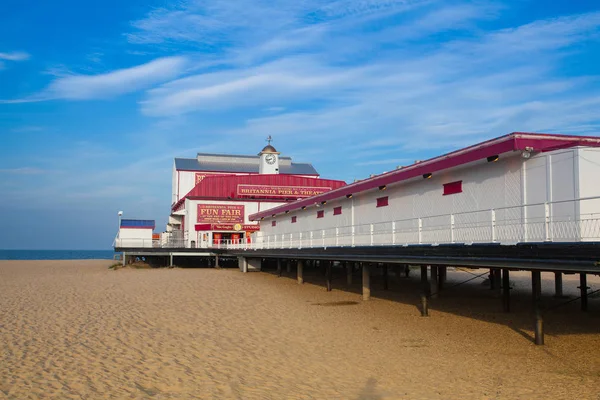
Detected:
left=172, top=174, right=346, bottom=211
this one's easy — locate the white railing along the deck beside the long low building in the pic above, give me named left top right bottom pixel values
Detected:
left=219, top=197, right=600, bottom=249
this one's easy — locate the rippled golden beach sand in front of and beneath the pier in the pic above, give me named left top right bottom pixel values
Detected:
left=0, top=261, right=600, bottom=399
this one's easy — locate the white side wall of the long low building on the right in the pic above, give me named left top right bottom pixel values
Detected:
left=260, top=149, right=600, bottom=245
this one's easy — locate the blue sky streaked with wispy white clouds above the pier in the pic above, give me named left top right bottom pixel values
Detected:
left=0, top=0, right=600, bottom=249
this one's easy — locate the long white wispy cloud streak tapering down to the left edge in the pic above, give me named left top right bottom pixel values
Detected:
left=3, top=57, right=188, bottom=103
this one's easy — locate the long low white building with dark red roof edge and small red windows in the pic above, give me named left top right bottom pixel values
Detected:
left=248, top=133, right=600, bottom=248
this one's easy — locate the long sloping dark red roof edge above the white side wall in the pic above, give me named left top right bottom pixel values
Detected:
left=249, top=132, right=600, bottom=221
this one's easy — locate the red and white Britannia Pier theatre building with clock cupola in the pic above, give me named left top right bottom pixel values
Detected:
left=169, top=144, right=346, bottom=248
